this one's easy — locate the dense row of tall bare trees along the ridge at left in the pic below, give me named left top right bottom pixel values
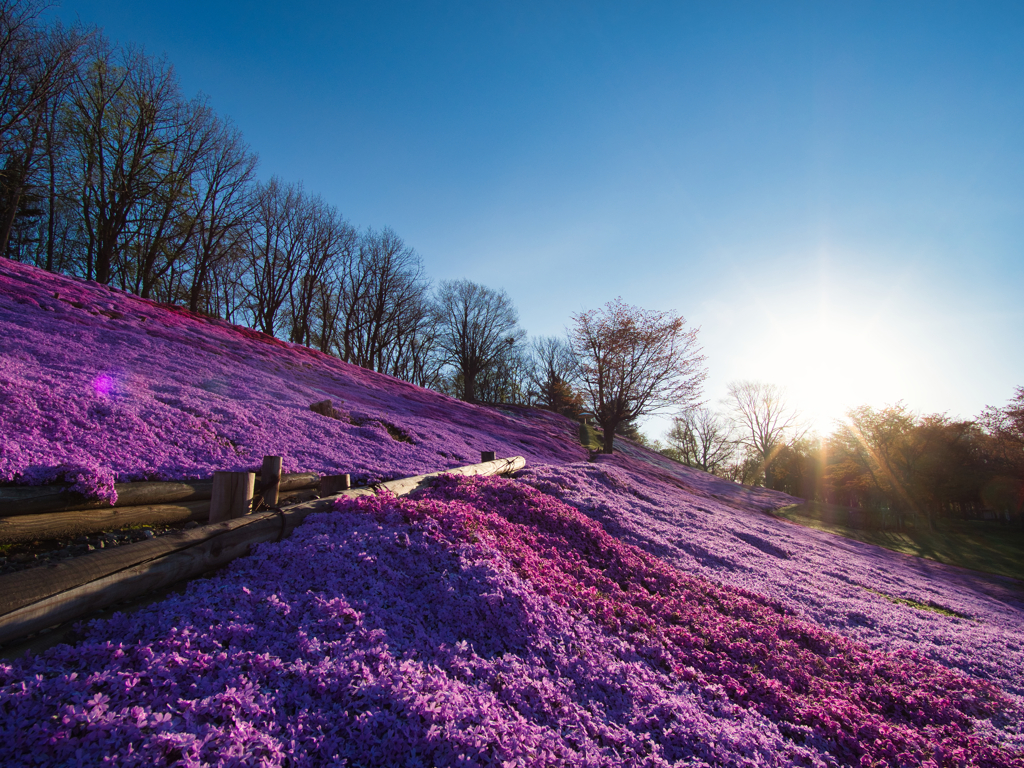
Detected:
left=0, top=0, right=712, bottom=421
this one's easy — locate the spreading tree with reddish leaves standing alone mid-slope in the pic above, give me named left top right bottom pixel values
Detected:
left=569, top=299, right=707, bottom=454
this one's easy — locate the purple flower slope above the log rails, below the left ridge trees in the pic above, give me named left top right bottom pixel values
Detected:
left=0, top=259, right=586, bottom=501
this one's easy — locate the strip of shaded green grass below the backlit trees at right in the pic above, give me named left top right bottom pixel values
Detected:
left=771, top=502, right=1024, bottom=580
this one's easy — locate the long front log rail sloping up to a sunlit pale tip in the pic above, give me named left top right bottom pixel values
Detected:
left=0, top=456, right=526, bottom=644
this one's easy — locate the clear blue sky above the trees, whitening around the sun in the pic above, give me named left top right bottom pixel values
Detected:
left=46, top=0, right=1024, bottom=436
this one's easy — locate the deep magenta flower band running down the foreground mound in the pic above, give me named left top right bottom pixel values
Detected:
left=409, top=477, right=1024, bottom=765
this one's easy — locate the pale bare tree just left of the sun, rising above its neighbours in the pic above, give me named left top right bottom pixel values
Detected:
left=727, top=381, right=804, bottom=487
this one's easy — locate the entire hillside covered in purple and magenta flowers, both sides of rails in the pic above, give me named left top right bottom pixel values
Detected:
left=0, top=262, right=1024, bottom=766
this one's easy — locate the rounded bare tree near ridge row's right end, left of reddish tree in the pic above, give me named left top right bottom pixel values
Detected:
left=433, top=280, right=525, bottom=402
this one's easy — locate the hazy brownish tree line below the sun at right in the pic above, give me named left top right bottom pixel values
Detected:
left=655, top=382, right=1024, bottom=528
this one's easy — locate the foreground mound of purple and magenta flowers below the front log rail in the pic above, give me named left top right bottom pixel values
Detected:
left=0, top=478, right=1022, bottom=766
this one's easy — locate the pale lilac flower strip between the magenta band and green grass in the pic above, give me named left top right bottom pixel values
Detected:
left=519, top=455, right=1024, bottom=708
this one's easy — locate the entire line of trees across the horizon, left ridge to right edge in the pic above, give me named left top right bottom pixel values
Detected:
left=8, top=0, right=1011, bottom=528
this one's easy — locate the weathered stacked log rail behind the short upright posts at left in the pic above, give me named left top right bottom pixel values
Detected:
left=0, top=472, right=321, bottom=544
